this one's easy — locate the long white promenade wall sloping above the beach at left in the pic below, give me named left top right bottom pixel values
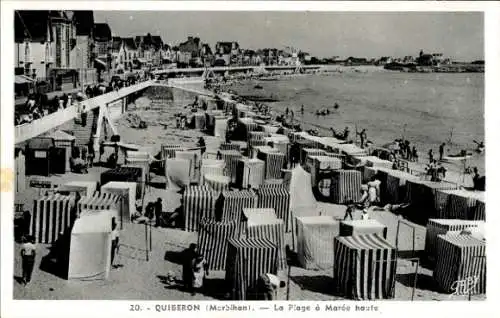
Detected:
left=14, top=81, right=153, bottom=144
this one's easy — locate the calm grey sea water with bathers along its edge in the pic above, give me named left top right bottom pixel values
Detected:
left=231, top=71, right=485, bottom=171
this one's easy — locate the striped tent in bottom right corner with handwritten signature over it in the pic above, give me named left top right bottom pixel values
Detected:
left=433, top=234, right=486, bottom=296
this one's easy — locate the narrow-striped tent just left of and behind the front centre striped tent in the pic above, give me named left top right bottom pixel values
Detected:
left=198, top=218, right=238, bottom=271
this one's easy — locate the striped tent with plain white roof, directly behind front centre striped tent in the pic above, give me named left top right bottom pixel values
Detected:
left=240, top=209, right=286, bottom=270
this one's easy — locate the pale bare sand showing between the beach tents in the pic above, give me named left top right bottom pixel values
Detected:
left=13, top=101, right=485, bottom=300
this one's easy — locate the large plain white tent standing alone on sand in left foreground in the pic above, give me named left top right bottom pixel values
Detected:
left=68, top=210, right=112, bottom=280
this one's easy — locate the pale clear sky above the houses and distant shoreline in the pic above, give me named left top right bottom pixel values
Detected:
left=94, top=11, right=484, bottom=61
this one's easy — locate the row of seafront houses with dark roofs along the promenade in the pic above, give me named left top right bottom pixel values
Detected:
left=14, top=10, right=310, bottom=80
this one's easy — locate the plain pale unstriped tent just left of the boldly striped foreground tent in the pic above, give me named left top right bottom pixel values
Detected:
left=296, top=216, right=339, bottom=270
